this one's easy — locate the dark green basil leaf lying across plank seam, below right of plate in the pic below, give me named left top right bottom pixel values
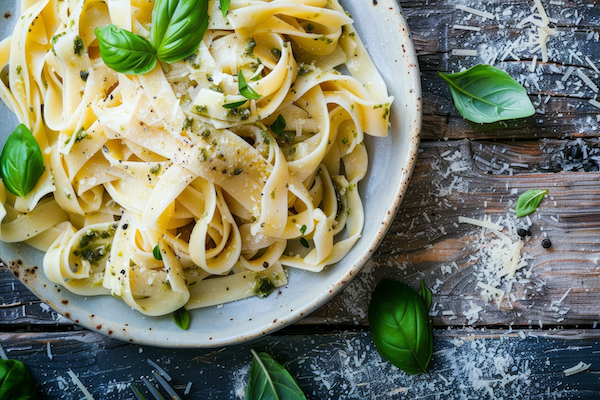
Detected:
left=369, top=279, right=433, bottom=374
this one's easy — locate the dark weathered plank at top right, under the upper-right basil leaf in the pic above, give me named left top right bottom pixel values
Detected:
left=399, top=0, right=600, bottom=139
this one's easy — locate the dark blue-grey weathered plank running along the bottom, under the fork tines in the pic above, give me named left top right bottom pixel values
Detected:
left=0, top=329, right=600, bottom=400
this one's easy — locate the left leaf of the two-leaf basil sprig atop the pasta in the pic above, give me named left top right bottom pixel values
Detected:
left=94, top=25, right=156, bottom=74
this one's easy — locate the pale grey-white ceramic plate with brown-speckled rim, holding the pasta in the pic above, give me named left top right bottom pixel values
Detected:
left=0, top=0, right=421, bottom=347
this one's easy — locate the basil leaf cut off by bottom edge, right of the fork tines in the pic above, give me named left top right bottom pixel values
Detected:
left=246, top=349, right=306, bottom=400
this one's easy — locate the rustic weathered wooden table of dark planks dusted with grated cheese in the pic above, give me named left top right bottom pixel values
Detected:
left=0, top=0, right=600, bottom=399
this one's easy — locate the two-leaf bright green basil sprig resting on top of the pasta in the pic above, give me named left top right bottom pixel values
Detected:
left=94, top=0, right=208, bottom=74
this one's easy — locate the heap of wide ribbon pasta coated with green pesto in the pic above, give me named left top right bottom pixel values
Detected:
left=0, top=0, right=393, bottom=316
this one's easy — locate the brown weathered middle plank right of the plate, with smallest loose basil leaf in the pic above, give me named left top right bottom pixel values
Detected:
left=300, top=140, right=600, bottom=326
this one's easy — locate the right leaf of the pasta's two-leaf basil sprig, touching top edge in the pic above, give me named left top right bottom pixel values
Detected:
left=150, top=0, right=208, bottom=63
